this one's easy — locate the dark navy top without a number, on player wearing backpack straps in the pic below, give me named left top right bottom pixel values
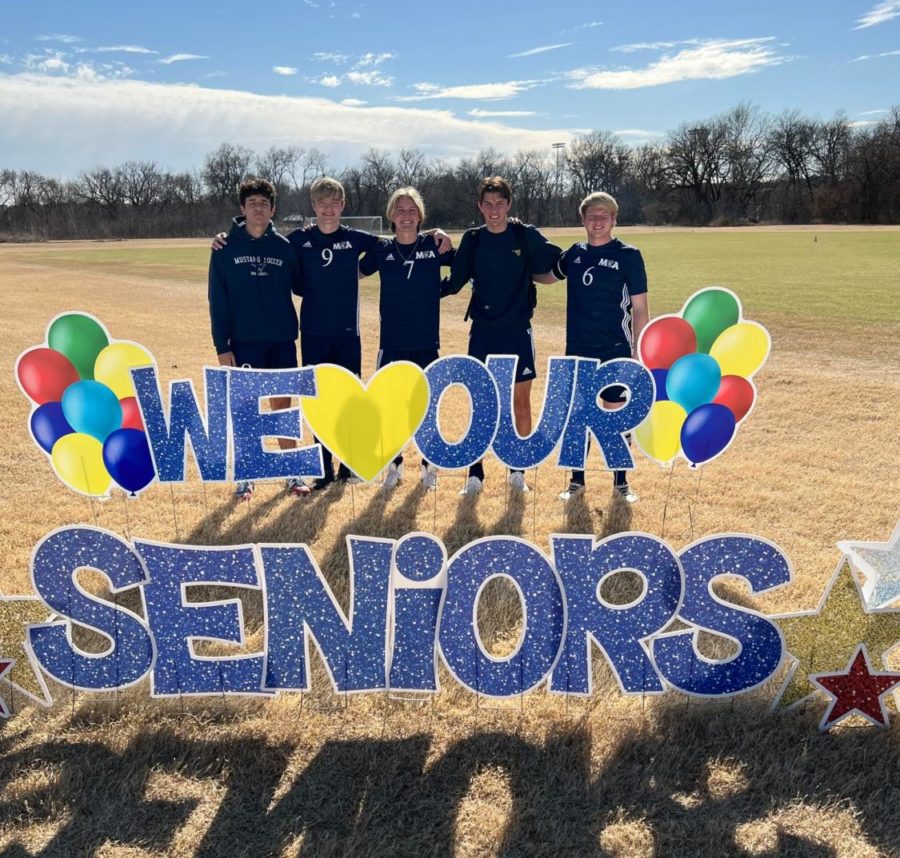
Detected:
left=448, top=224, right=562, bottom=329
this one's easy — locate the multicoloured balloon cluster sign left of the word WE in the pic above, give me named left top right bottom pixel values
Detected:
left=16, top=313, right=156, bottom=497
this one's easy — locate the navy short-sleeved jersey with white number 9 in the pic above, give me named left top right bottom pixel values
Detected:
left=288, top=226, right=380, bottom=337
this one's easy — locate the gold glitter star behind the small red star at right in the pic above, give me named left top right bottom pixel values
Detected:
left=770, top=558, right=900, bottom=708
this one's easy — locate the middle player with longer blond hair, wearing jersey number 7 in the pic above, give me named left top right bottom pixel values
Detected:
left=359, top=187, right=453, bottom=489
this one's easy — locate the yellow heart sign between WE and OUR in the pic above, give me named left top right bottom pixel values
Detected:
left=301, top=361, right=431, bottom=480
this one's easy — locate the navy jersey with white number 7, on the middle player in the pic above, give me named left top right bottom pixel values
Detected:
left=359, top=233, right=453, bottom=351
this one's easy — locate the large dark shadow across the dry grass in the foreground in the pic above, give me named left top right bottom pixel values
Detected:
left=0, top=703, right=900, bottom=858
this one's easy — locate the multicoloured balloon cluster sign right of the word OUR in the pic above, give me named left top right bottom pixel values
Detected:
left=635, top=287, right=771, bottom=465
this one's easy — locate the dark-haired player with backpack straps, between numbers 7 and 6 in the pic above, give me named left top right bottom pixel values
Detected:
left=448, top=176, right=561, bottom=495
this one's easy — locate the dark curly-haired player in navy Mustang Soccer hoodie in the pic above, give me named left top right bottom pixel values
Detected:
left=209, top=179, right=301, bottom=500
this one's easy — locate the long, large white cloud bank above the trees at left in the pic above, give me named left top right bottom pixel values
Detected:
left=0, top=74, right=572, bottom=177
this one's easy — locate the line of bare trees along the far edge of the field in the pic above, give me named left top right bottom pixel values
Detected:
left=0, top=103, right=900, bottom=240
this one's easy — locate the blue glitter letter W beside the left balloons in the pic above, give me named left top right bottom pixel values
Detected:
left=131, top=367, right=228, bottom=483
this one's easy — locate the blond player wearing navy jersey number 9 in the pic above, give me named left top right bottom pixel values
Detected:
left=213, top=176, right=450, bottom=494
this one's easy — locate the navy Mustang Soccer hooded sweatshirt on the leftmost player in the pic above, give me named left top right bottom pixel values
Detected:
left=209, top=217, right=301, bottom=354
